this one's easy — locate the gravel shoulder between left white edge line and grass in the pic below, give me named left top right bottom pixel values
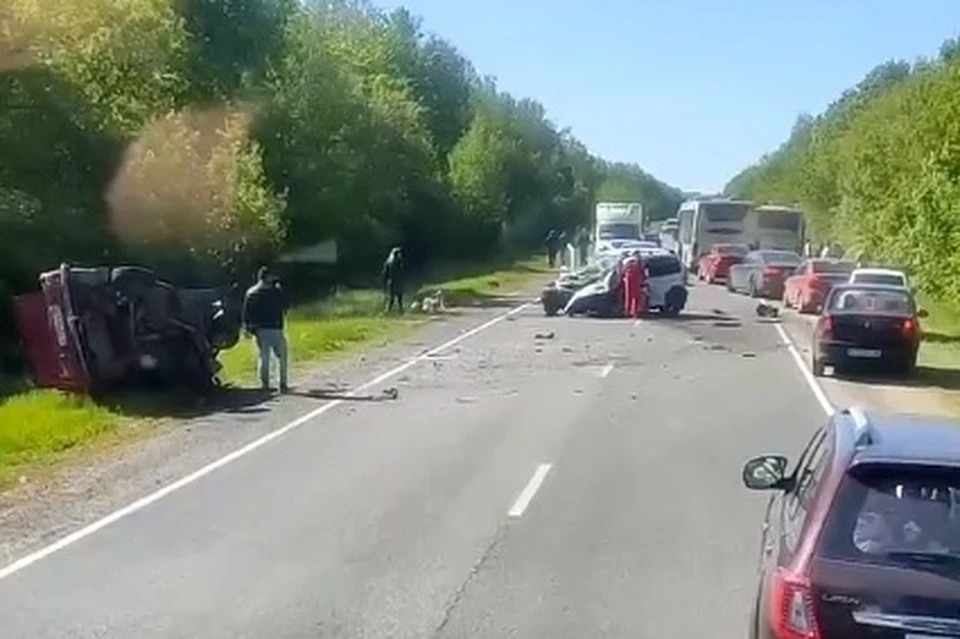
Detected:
left=0, top=292, right=531, bottom=564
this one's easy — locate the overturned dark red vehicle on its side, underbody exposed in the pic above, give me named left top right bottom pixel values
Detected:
left=16, top=264, right=241, bottom=393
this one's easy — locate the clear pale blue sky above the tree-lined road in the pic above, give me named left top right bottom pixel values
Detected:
left=374, top=0, right=960, bottom=191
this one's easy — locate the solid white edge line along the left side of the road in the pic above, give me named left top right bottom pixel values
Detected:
left=0, top=303, right=530, bottom=579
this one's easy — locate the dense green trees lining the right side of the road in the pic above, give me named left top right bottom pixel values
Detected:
left=726, top=40, right=960, bottom=302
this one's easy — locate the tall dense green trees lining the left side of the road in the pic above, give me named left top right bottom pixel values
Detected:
left=0, top=0, right=679, bottom=370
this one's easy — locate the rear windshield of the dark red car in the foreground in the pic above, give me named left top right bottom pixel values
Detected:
left=820, top=464, right=960, bottom=565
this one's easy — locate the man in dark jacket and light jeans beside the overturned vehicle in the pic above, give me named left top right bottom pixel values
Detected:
left=243, top=266, right=289, bottom=392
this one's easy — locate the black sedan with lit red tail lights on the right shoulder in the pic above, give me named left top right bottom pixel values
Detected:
left=810, top=284, right=926, bottom=376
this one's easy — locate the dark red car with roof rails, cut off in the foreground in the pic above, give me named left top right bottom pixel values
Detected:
left=742, top=409, right=960, bottom=639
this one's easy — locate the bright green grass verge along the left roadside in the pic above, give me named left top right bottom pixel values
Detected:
left=0, top=259, right=549, bottom=489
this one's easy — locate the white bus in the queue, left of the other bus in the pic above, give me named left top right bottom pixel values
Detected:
left=677, top=198, right=754, bottom=270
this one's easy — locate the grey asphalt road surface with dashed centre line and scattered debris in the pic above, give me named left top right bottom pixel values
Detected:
left=0, top=286, right=825, bottom=639
